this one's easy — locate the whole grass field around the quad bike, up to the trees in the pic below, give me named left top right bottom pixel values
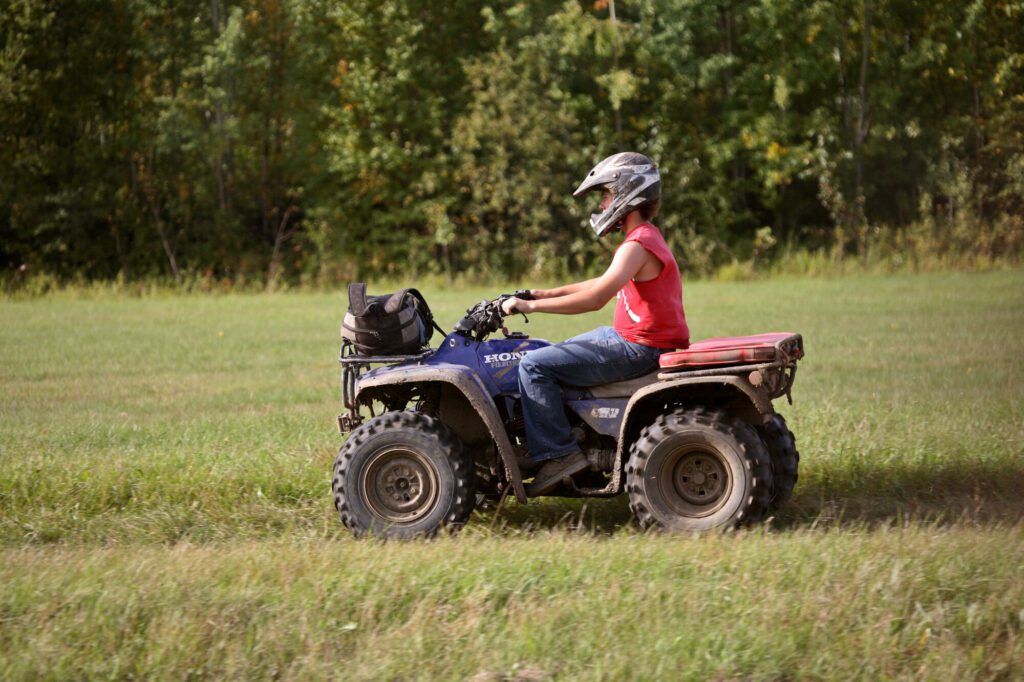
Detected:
left=0, top=270, right=1024, bottom=680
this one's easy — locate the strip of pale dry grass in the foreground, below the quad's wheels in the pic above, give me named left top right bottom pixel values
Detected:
left=0, top=526, right=1024, bottom=680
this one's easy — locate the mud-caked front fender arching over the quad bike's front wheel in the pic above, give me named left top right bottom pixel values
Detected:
left=356, top=364, right=526, bottom=504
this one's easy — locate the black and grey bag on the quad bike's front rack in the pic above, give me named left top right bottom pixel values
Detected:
left=341, top=283, right=436, bottom=355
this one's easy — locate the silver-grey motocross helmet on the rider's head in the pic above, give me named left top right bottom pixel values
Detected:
left=572, top=152, right=662, bottom=237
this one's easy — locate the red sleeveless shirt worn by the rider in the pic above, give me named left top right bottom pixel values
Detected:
left=613, top=222, right=690, bottom=348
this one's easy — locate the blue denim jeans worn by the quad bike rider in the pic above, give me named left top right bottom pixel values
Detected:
left=519, top=327, right=670, bottom=461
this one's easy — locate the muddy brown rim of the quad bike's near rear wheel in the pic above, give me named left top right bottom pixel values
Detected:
left=655, top=445, right=732, bottom=517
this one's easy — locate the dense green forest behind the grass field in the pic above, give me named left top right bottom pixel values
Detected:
left=0, top=0, right=1024, bottom=290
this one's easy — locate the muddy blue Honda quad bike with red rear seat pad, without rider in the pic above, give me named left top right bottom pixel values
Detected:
left=332, top=292, right=804, bottom=538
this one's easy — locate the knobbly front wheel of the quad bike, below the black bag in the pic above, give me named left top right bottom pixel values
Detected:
left=331, top=412, right=475, bottom=539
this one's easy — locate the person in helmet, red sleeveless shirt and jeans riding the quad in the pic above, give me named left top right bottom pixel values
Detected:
left=502, top=152, right=689, bottom=496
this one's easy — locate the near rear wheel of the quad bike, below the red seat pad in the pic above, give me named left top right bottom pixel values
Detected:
left=626, top=409, right=772, bottom=532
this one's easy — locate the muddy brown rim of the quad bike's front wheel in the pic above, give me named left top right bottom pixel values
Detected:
left=361, top=447, right=438, bottom=524
